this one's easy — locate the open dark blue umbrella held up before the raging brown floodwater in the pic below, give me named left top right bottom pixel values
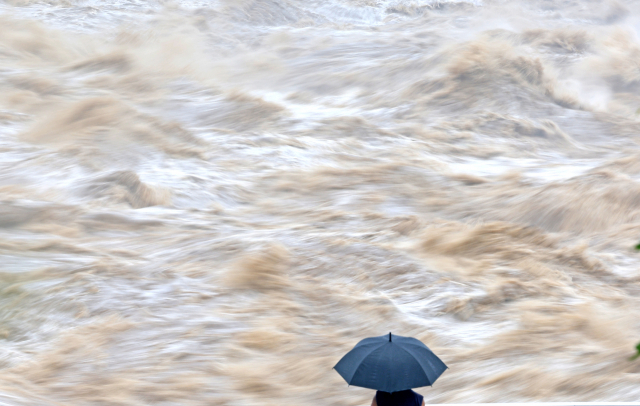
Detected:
left=333, top=333, right=447, bottom=392
